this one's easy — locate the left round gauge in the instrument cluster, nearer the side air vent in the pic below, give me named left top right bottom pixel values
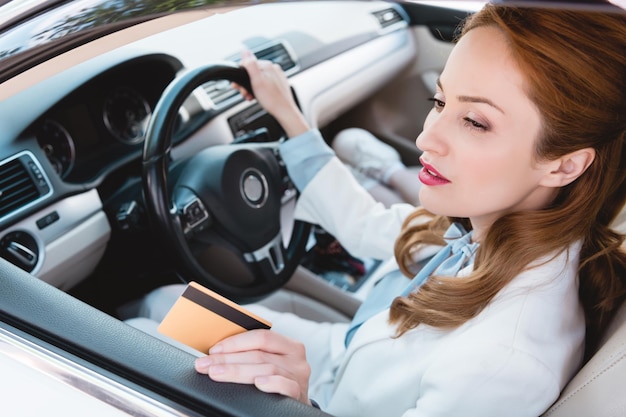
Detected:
left=37, top=119, right=76, bottom=178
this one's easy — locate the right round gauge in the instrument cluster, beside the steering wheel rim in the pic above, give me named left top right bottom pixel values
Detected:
left=103, top=87, right=151, bottom=145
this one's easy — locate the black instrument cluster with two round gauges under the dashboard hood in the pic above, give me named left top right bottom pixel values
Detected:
left=33, top=57, right=180, bottom=183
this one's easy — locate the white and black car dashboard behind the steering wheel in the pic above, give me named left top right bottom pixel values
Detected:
left=0, top=1, right=450, bottom=298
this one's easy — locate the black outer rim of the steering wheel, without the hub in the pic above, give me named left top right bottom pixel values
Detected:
left=142, top=63, right=310, bottom=302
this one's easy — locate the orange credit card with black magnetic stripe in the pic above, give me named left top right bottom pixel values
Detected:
left=158, top=282, right=272, bottom=353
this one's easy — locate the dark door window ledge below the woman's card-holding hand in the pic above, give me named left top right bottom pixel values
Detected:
left=0, top=259, right=328, bottom=417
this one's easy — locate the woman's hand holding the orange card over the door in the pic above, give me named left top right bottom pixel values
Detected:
left=195, top=330, right=311, bottom=405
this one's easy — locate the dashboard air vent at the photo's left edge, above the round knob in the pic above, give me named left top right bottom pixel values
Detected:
left=0, top=152, right=51, bottom=218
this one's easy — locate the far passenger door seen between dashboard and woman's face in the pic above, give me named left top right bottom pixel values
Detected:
left=328, top=2, right=478, bottom=166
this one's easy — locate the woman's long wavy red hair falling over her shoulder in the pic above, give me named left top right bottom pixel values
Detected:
left=390, top=4, right=626, bottom=355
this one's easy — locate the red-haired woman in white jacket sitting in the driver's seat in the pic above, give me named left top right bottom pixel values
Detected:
left=146, top=5, right=626, bottom=417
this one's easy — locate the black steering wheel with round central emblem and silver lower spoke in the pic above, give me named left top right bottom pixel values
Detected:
left=142, top=64, right=310, bottom=302
